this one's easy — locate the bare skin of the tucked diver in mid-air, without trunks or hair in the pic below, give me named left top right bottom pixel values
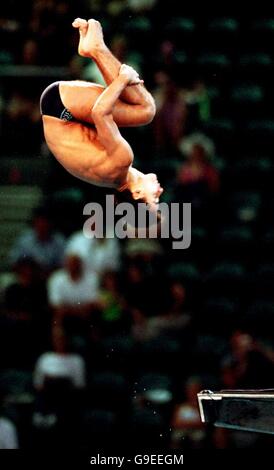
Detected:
left=43, top=18, right=163, bottom=204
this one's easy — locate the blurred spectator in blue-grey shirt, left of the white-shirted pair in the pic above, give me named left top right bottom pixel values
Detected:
left=10, top=207, right=64, bottom=275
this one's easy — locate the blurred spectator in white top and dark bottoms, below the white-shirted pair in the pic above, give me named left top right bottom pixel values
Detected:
left=31, top=326, right=86, bottom=449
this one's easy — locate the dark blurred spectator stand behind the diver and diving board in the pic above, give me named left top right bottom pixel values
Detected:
left=0, top=0, right=274, bottom=450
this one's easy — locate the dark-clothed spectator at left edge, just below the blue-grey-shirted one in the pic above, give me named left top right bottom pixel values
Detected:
left=0, top=258, right=50, bottom=367
